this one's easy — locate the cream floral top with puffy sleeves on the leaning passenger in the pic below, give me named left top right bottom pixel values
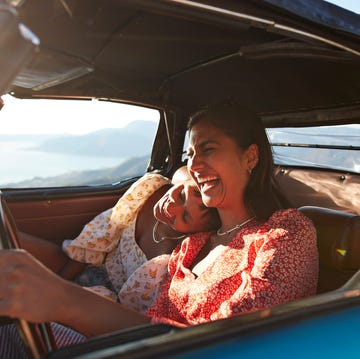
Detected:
left=63, top=174, right=171, bottom=312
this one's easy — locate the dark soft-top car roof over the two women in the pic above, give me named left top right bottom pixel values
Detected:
left=11, top=0, right=360, bottom=126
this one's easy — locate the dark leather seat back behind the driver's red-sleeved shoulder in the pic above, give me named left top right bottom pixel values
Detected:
left=299, top=206, right=360, bottom=293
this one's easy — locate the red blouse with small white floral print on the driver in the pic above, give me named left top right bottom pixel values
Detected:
left=146, top=209, right=318, bottom=326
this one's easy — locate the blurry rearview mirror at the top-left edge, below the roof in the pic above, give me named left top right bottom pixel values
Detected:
left=0, top=5, right=40, bottom=95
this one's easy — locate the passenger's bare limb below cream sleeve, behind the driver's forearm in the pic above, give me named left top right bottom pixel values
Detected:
left=18, top=232, right=85, bottom=279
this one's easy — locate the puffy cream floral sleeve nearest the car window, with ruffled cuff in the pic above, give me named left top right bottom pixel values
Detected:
left=63, top=173, right=171, bottom=265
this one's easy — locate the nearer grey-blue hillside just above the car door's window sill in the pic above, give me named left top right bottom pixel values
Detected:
left=4, top=155, right=149, bottom=188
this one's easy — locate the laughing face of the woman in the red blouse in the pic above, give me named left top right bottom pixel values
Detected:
left=188, top=120, right=249, bottom=208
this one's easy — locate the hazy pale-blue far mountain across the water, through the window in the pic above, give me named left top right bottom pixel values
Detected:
left=31, top=121, right=157, bottom=158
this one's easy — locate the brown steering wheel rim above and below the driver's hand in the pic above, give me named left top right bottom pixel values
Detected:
left=0, top=191, right=56, bottom=359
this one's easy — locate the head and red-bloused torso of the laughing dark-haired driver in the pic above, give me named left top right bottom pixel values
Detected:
left=147, top=104, right=318, bottom=326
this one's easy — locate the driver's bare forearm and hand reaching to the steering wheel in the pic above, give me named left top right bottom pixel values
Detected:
left=0, top=250, right=150, bottom=337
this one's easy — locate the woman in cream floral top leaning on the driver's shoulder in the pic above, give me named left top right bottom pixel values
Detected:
left=20, top=167, right=218, bottom=312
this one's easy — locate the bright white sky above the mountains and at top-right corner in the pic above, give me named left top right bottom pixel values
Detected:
left=0, top=0, right=360, bottom=134
